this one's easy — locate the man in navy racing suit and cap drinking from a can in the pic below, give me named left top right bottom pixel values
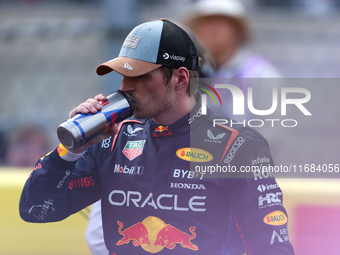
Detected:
left=20, top=19, right=294, bottom=255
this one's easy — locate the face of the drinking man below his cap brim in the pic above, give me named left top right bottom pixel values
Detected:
left=120, top=68, right=175, bottom=119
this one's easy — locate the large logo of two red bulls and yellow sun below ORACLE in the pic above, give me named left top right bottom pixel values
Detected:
left=116, top=216, right=198, bottom=253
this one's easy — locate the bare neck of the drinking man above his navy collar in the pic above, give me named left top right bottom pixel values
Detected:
left=152, top=95, right=197, bottom=125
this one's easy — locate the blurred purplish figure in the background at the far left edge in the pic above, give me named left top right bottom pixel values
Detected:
left=4, top=126, right=49, bottom=167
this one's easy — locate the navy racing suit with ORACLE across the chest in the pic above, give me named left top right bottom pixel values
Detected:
left=20, top=95, right=294, bottom=255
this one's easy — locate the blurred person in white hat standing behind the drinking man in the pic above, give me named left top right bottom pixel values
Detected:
left=181, top=0, right=282, bottom=129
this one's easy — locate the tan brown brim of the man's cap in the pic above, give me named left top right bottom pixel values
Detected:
left=96, top=57, right=162, bottom=77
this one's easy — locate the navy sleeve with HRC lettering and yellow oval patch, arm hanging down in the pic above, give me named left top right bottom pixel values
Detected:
left=230, top=138, right=294, bottom=255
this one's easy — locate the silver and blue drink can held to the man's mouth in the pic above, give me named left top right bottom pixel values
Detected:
left=57, top=90, right=133, bottom=150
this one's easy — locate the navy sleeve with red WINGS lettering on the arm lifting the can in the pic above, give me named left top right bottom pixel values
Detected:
left=19, top=147, right=100, bottom=222
